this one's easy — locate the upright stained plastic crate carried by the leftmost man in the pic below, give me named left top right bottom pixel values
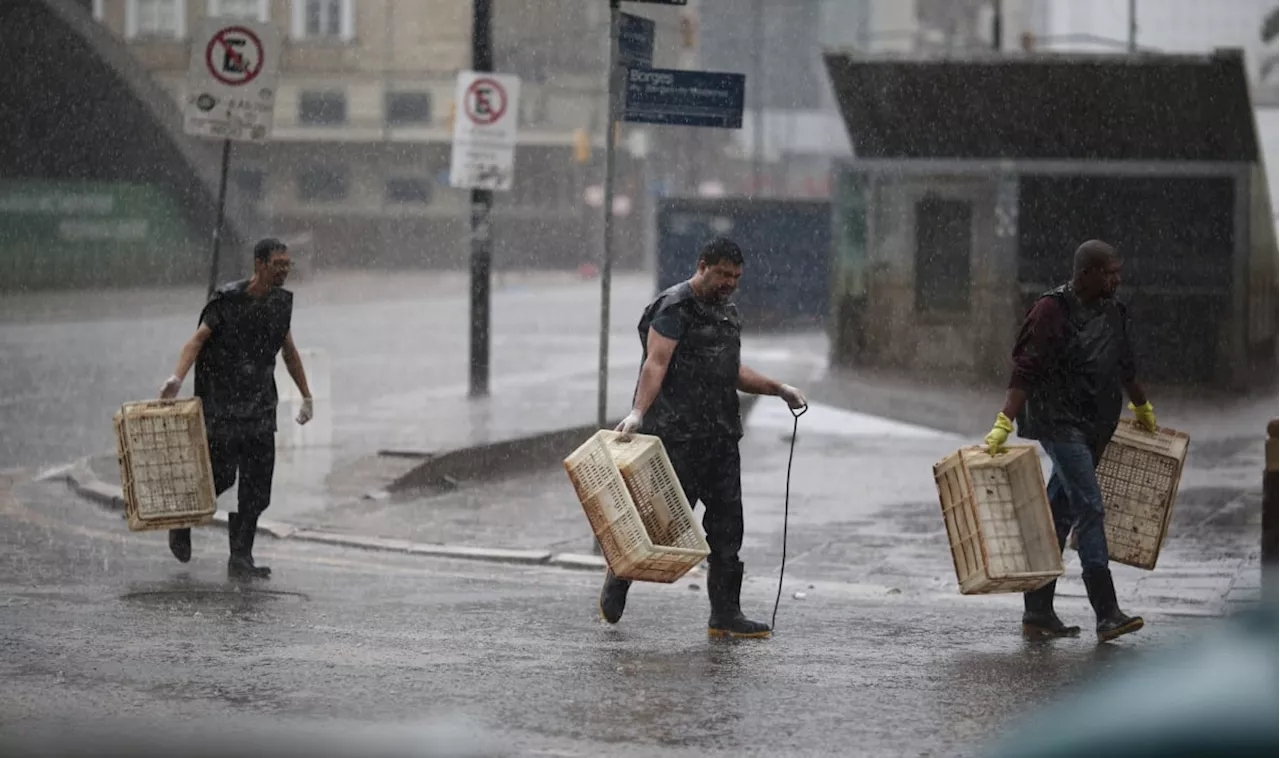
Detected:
left=111, top=397, right=218, bottom=531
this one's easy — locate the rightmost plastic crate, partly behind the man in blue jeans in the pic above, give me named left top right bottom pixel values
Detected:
left=1090, top=419, right=1190, bottom=570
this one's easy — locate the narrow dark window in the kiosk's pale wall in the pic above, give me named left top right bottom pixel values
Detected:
left=915, top=196, right=973, bottom=312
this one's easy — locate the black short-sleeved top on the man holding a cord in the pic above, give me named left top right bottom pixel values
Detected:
left=639, top=282, right=742, bottom=443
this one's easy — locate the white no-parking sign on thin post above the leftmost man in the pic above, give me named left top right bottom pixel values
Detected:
left=182, top=18, right=282, bottom=142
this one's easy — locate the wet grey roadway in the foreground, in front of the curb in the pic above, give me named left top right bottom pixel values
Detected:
left=0, top=478, right=1211, bottom=755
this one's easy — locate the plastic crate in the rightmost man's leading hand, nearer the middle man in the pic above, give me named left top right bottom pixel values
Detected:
left=933, top=444, right=1062, bottom=595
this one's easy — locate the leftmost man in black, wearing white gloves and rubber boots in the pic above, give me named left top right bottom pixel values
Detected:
left=160, top=238, right=312, bottom=577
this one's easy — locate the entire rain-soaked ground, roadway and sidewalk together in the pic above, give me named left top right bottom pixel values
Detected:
left=0, top=274, right=1267, bottom=758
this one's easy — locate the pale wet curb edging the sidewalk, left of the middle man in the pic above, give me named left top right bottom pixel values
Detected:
left=62, top=457, right=605, bottom=571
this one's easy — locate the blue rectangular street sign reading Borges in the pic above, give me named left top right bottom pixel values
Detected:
left=622, top=68, right=746, bottom=129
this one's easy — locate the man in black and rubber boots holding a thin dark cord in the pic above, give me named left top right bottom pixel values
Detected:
left=600, top=238, right=805, bottom=638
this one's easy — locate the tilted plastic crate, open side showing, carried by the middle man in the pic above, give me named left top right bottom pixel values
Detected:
left=564, top=429, right=710, bottom=584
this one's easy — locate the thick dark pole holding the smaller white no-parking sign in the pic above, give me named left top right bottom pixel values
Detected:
left=471, top=0, right=493, bottom=397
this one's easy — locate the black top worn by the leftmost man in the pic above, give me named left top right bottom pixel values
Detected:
left=196, top=280, right=293, bottom=430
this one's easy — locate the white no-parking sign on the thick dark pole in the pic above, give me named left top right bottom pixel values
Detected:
left=449, top=72, right=520, bottom=192
